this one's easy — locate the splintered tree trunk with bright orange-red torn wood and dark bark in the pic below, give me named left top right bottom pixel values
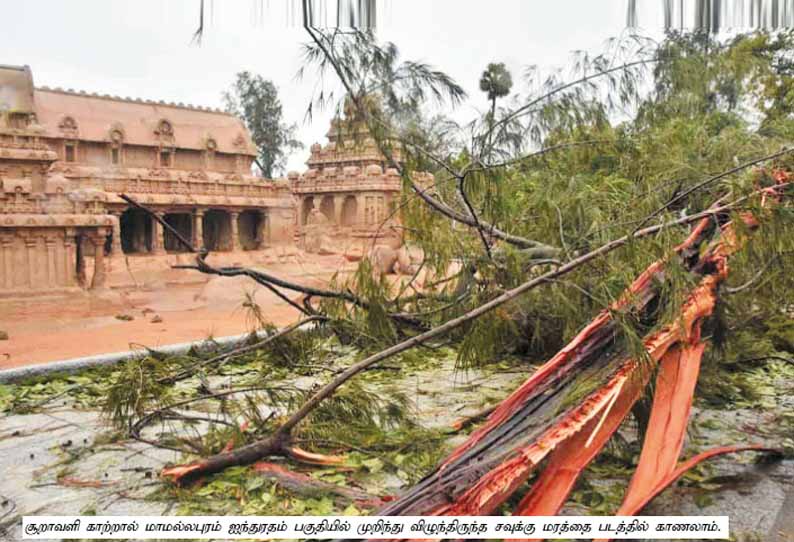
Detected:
left=364, top=183, right=777, bottom=532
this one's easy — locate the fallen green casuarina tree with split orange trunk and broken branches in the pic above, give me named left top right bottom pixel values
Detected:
left=96, top=19, right=791, bottom=524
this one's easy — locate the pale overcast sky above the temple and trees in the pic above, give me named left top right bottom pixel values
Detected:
left=0, top=0, right=656, bottom=170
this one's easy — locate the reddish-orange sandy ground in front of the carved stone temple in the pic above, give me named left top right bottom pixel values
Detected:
left=0, top=256, right=346, bottom=369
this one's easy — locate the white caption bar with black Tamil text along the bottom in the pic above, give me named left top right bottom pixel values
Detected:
left=22, top=516, right=728, bottom=540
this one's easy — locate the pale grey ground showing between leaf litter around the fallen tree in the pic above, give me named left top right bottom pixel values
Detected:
left=0, top=360, right=794, bottom=542
